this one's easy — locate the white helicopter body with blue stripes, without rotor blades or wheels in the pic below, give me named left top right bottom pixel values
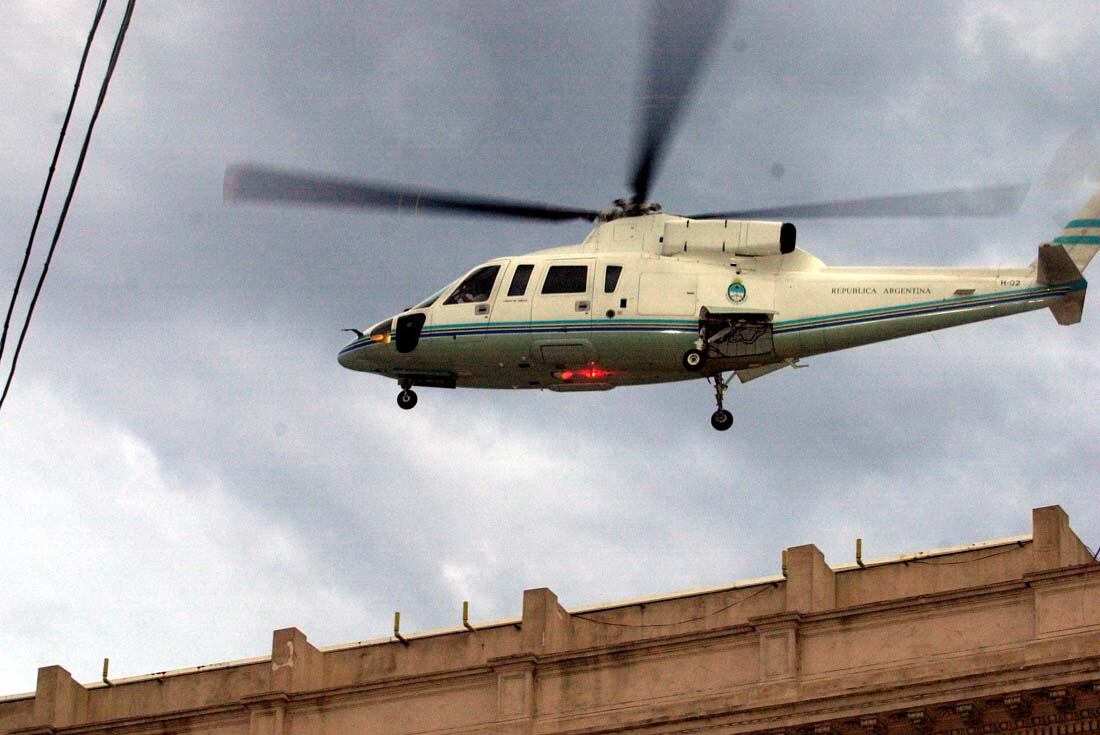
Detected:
left=339, top=215, right=1086, bottom=392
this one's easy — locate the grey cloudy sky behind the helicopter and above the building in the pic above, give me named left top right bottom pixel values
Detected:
left=0, top=0, right=1100, bottom=693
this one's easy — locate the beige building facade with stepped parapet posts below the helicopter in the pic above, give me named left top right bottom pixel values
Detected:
left=0, top=506, right=1100, bottom=735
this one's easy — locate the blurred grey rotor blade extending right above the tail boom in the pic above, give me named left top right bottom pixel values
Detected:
left=691, top=184, right=1027, bottom=219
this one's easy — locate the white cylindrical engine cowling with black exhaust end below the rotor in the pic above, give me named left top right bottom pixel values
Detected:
left=661, top=219, right=796, bottom=256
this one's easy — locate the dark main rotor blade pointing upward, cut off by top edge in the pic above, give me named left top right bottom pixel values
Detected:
left=627, top=0, right=734, bottom=204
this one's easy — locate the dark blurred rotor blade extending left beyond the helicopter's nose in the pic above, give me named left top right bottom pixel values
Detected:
left=224, top=164, right=600, bottom=221
